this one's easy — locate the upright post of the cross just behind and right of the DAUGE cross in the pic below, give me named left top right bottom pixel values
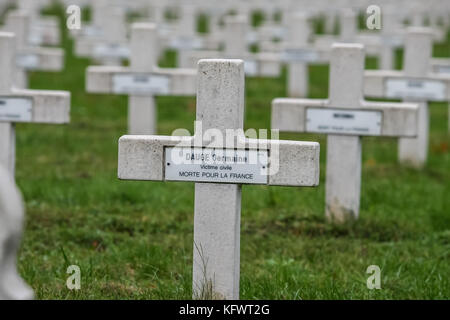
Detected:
left=325, top=45, right=364, bottom=220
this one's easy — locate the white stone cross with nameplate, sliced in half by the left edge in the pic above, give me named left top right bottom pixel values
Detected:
left=0, top=32, right=70, bottom=175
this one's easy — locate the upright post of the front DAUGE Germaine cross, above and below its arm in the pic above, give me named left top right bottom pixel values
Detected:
left=193, top=58, right=245, bottom=298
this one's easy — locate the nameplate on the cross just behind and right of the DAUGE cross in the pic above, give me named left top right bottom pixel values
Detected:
left=306, top=108, right=382, bottom=136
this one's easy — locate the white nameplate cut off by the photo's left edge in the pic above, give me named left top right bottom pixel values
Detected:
left=0, top=97, right=33, bottom=122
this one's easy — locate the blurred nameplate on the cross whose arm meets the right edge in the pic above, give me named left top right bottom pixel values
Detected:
left=385, top=79, right=446, bottom=101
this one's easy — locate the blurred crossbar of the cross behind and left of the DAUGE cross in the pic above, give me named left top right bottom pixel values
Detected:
left=86, top=66, right=197, bottom=96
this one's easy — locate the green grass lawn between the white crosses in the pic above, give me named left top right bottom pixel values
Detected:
left=9, top=2, right=450, bottom=299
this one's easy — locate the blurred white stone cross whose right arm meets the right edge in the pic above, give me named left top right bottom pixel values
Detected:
left=364, top=27, right=450, bottom=168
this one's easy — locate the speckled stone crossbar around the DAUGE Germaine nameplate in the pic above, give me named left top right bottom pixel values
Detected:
left=118, top=135, right=320, bottom=186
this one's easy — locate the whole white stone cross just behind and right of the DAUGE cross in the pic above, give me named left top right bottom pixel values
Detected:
left=272, top=44, right=418, bottom=223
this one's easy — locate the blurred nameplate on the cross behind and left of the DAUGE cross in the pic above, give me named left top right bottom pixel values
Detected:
left=113, top=74, right=170, bottom=96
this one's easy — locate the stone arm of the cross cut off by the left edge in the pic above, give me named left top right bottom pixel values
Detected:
left=0, top=89, right=70, bottom=124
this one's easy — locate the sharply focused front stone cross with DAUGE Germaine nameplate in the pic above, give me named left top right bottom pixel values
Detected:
left=118, top=60, right=319, bottom=299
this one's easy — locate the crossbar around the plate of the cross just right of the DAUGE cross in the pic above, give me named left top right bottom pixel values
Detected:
left=271, top=98, right=418, bottom=137
